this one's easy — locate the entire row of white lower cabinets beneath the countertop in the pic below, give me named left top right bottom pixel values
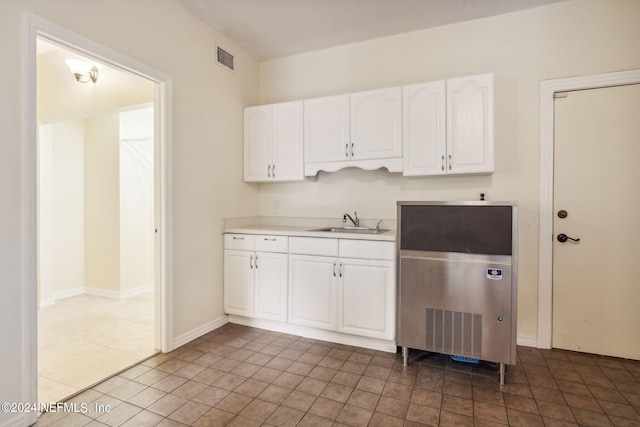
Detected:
left=224, top=234, right=395, bottom=342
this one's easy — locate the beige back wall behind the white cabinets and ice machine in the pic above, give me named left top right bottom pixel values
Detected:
left=260, top=0, right=640, bottom=338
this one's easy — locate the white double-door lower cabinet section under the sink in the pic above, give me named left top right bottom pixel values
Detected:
left=289, top=237, right=395, bottom=340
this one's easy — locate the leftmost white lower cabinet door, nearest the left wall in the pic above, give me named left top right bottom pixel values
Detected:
left=224, top=250, right=255, bottom=316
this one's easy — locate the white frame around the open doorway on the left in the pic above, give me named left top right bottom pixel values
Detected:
left=20, top=12, right=174, bottom=424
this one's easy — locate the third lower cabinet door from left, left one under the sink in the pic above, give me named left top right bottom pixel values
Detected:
left=289, top=255, right=337, bottom=331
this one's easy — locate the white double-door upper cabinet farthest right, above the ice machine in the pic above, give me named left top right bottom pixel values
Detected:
left=403, top=74, right=494, bottom=175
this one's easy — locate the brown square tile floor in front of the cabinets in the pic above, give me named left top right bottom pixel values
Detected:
left=37, top=324, right=640, bottom=427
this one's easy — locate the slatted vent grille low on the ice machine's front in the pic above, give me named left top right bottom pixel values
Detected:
left=425, top=308, right=482, bottom=358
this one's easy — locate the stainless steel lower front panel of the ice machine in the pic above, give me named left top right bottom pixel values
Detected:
left=397, top=253, right=515, bottom=364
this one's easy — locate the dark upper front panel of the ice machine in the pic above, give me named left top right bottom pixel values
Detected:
left=400, top=205, right=513, bottom=255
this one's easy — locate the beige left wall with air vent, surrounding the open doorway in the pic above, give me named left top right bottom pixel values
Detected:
left=0, top=0, right=259, bottom=425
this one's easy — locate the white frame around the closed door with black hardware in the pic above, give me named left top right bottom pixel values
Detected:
left=537, top=70, right=640, bottom=348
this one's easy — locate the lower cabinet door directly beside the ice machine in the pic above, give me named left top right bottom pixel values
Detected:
left=338, top=259, right=395, bottom=339
